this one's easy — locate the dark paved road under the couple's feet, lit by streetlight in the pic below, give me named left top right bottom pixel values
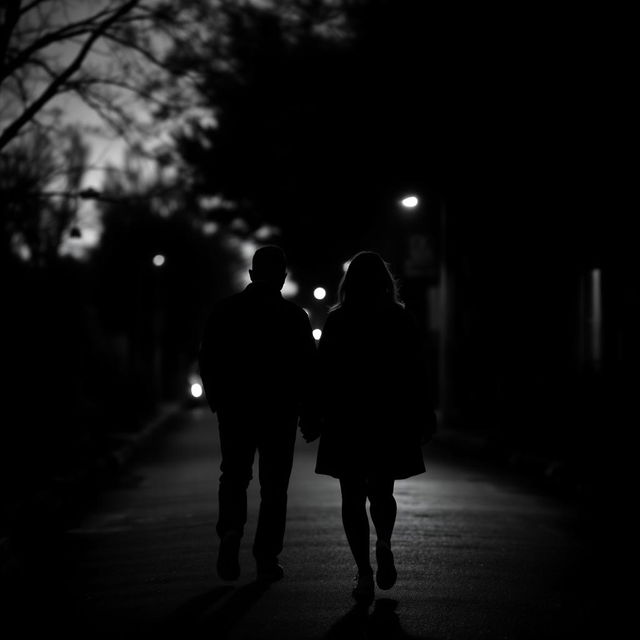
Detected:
left=4, top=409, right=595, bottom=640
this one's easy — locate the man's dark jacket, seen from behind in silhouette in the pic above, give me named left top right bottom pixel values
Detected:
left=199, top=283, right=316, bottom=414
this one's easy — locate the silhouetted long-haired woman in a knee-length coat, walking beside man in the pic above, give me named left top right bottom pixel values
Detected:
left=303, top=251, right=436, bottom=601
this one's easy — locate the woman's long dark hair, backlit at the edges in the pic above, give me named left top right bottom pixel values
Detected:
left=334, top=251, right=404, bottom=308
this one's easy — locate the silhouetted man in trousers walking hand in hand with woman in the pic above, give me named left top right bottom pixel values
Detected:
left=199, top=245, right=316, bottom=581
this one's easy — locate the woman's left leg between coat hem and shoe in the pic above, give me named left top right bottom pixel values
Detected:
left=340, top=478, right=372, bottom=572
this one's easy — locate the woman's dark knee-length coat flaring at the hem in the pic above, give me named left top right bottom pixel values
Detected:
left=316, top=303, right=435, bottom=479
